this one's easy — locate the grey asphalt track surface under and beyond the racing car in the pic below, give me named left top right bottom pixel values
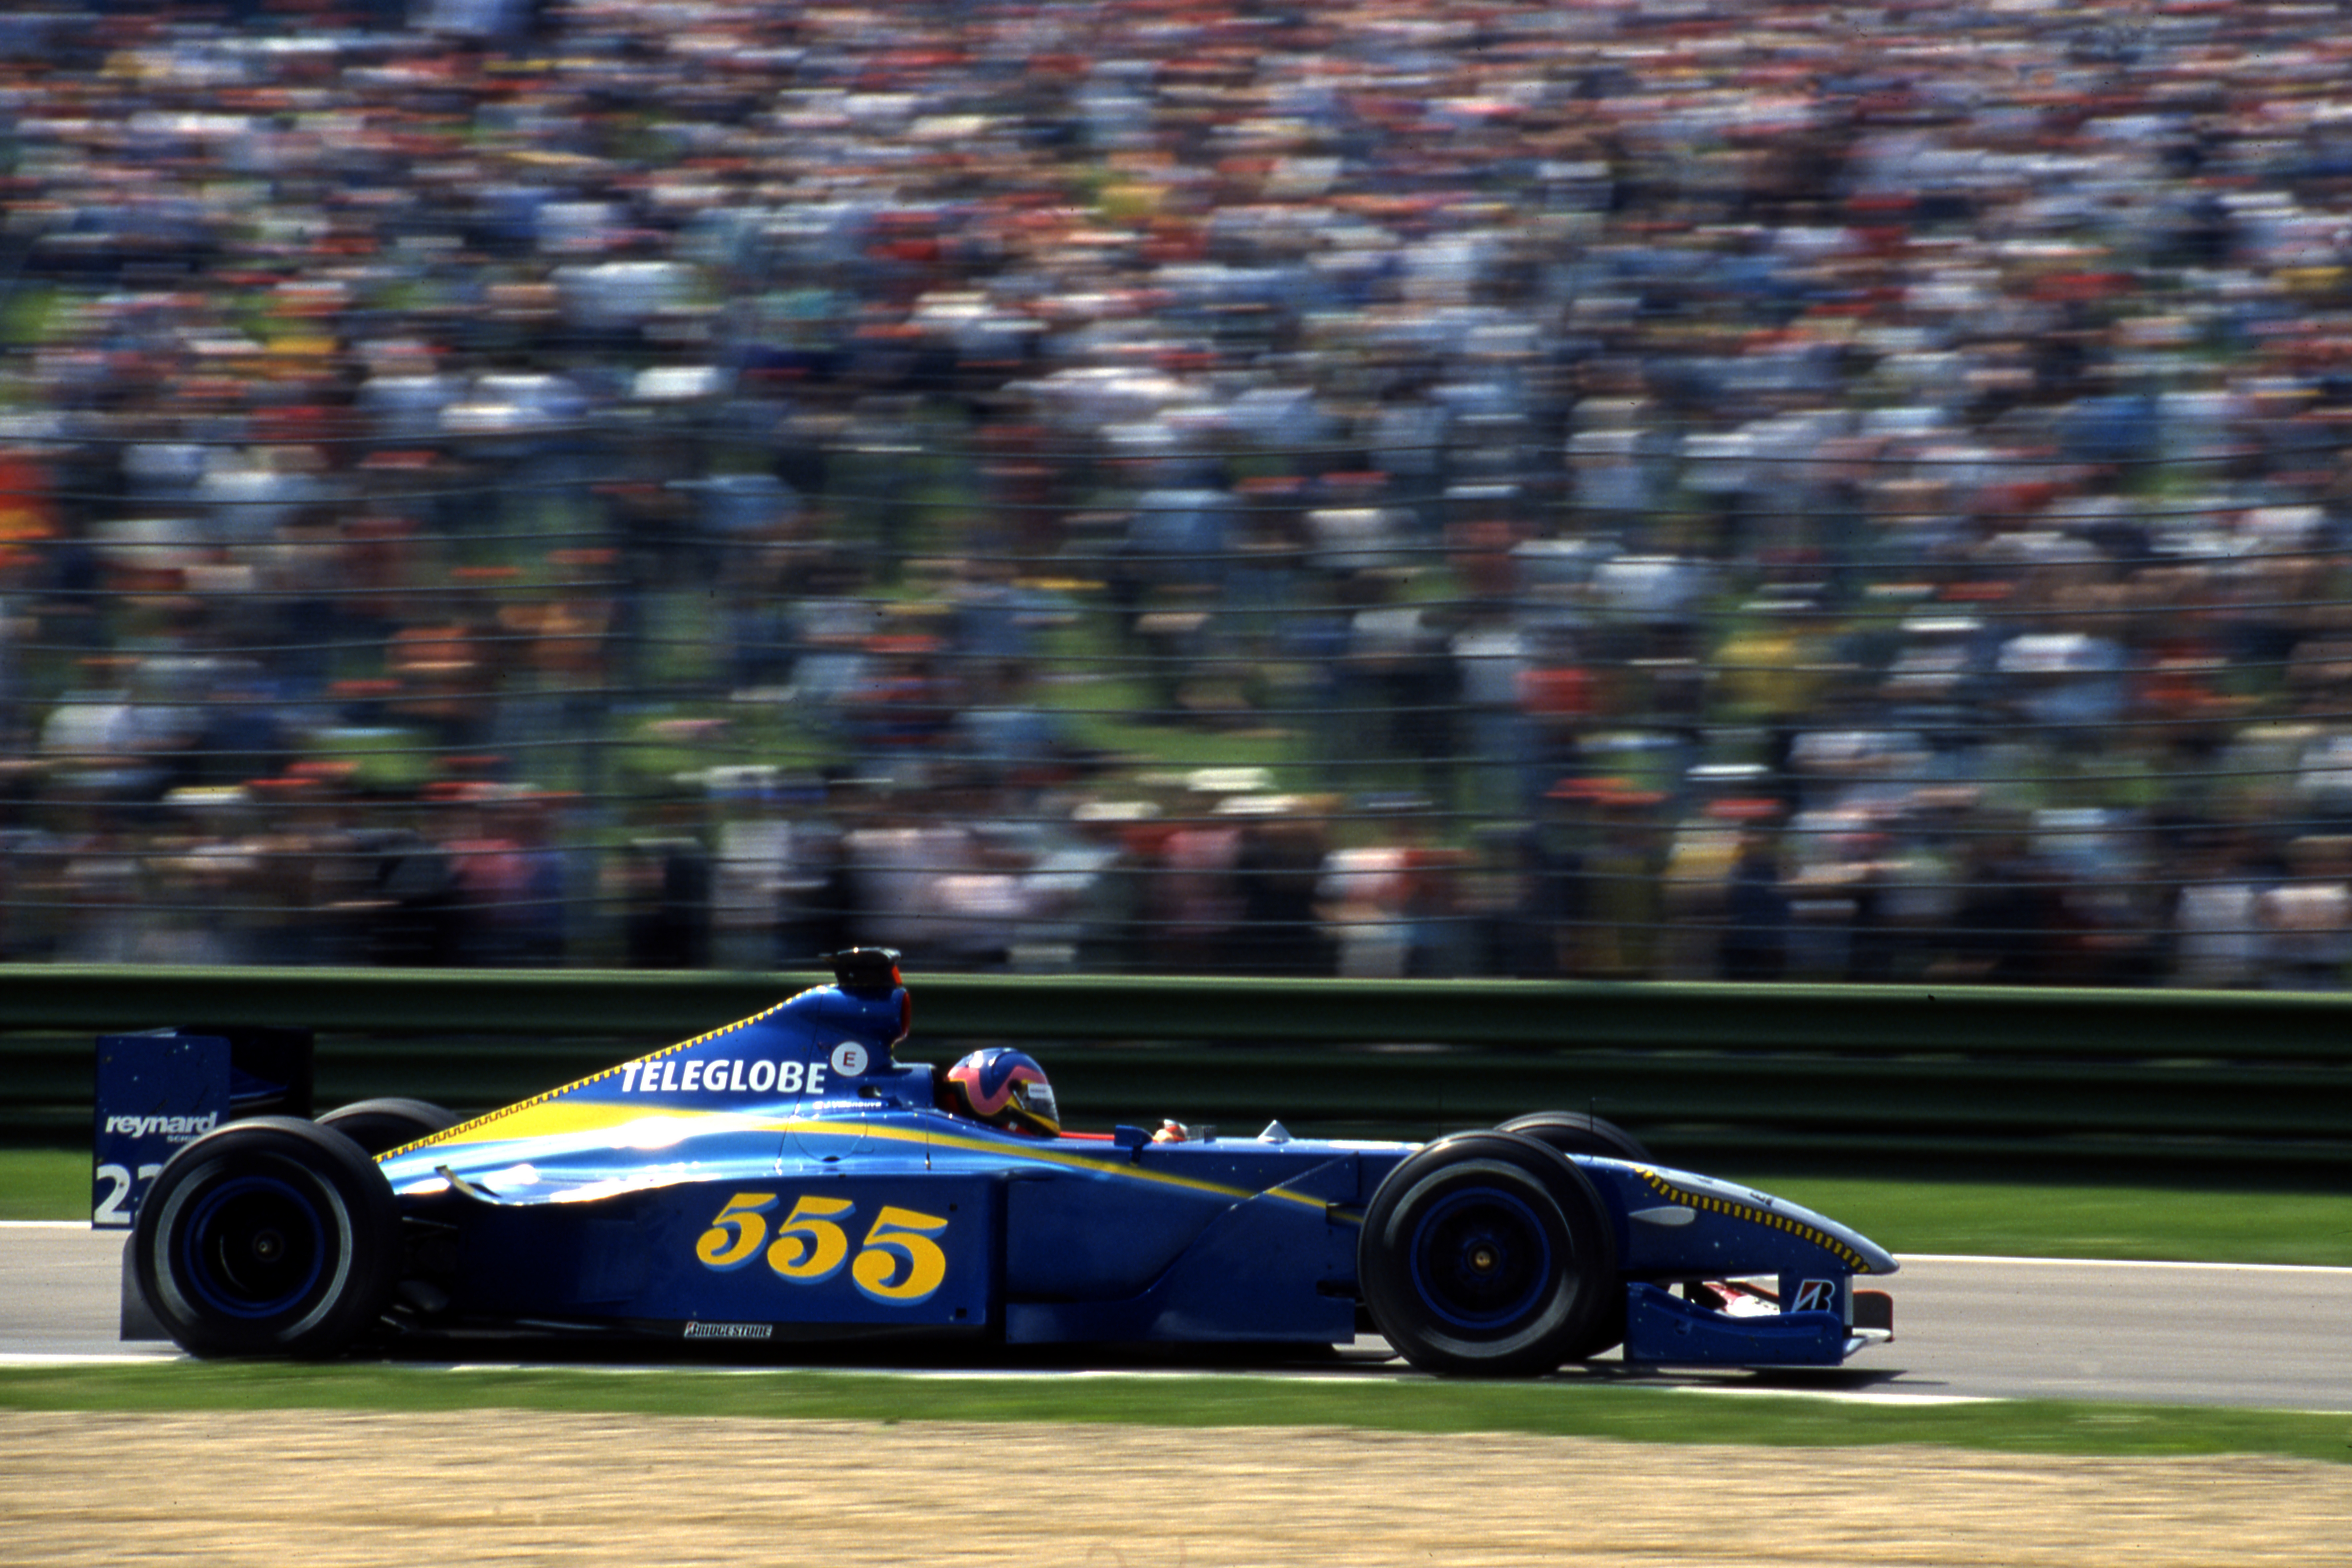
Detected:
left=14, top=1222, right=2352, bottom=1411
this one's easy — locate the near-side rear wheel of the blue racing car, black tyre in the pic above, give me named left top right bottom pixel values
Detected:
left=132, top=1116, right=400, bottom=1357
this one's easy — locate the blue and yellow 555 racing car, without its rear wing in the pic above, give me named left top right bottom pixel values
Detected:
left=119, top=950, right=1896, bottom=1375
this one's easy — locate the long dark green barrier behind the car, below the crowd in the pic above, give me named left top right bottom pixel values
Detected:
left=0, top=966, right=2352, bottom=1173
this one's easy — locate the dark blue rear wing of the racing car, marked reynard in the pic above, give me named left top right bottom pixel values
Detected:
left=89, top=1027, right=315, bottom=1229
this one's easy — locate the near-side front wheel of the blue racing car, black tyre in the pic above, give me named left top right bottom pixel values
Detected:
left=1355, top=1131, right=1623, bottom=1377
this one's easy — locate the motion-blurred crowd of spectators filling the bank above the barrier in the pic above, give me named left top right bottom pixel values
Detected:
left=0, top=0, right=2352, bottom=987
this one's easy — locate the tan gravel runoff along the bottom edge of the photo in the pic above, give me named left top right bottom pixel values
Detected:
left=0, top=1411, right=2352, bottom=1568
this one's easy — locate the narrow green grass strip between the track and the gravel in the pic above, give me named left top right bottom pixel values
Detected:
left=0, top=1361, right=2352, bottom=1464
